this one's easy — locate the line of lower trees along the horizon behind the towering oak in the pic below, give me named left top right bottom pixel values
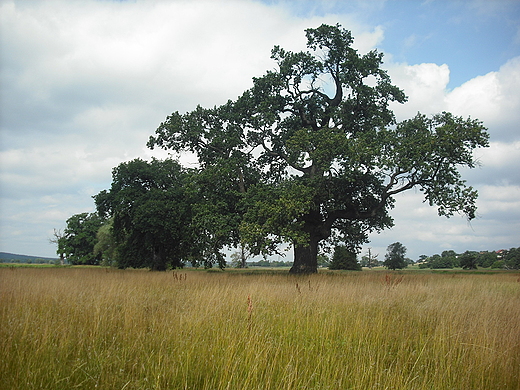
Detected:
left=52, top=197, right=520, bottom=270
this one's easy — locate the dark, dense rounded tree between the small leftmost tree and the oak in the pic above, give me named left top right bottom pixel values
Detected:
left=94, top=159, right=202, bottom=271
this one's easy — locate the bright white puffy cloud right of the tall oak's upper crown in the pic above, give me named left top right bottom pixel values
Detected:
left=389, top=57, right=520, bottom=145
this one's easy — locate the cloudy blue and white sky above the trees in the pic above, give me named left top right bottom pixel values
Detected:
left=0, top=0, right=520, bottom=259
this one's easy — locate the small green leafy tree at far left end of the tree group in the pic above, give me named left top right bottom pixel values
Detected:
left=60, top=213, right=103, bottom=265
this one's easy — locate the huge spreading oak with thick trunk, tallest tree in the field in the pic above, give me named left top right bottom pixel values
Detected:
left=148, top=25, right=488, bottom=273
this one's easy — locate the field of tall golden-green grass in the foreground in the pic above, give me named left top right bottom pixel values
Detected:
left=0, top=268, right=520, bottom=390
